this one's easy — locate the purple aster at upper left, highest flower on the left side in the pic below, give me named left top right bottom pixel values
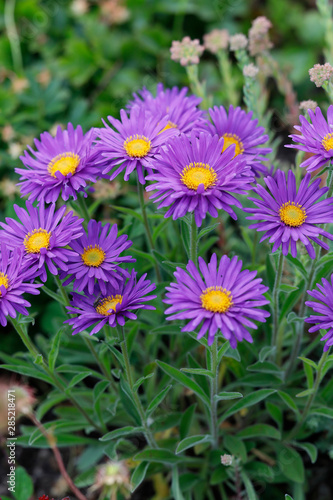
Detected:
left=15, top=123, right=102, bottom=203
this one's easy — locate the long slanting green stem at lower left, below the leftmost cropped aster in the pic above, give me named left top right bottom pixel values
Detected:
left=11, top=318, right=106, bottom=433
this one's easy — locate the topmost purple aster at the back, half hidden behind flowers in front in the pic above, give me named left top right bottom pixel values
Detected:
left=129, top=83, right=204, bottom=134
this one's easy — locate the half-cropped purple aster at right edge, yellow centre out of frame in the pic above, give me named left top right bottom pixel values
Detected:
left=305, top=274, right=333, bottom=351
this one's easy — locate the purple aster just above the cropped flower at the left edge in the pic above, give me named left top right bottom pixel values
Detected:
left=0, top=201, right=83, bottom=281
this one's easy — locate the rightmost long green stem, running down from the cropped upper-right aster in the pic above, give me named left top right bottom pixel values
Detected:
left=286, top=166, right=333, bottom=379
